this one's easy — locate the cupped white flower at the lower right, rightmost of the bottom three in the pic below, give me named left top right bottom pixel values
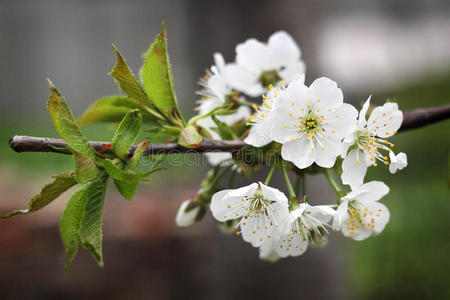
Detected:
left=333, top=181, right=389, bottom=241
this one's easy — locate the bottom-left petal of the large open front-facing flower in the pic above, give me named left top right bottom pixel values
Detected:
left=281, top=138, right=315, bottom=169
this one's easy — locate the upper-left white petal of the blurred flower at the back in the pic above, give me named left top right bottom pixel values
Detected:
left=236, top=39, right=273, bottom=75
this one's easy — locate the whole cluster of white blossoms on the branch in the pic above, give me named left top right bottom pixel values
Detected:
left=177, top=31, right=407, bottom=261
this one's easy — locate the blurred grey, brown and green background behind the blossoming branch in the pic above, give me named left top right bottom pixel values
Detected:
left=0, top=0, right=450, bottom=299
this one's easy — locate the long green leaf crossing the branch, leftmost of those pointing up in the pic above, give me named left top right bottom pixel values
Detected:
left=47, top=80, right=100, bottom=183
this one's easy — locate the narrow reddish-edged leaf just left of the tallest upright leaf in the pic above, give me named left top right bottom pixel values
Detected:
left=108, top=45, right=158, bottom=112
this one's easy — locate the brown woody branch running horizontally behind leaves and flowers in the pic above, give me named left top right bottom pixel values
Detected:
left=9, top=105, right=450, bottom=155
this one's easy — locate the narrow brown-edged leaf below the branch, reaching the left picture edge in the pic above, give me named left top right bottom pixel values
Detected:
left=0, top=173, right=77, bottom=218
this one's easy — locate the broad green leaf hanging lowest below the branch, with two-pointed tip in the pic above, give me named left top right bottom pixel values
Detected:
left=59, top=179, right=106, bottom=272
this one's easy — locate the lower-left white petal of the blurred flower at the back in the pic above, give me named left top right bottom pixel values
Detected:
left=224, top=64, right=265, bottom=97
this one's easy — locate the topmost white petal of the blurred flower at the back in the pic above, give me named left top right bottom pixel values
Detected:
left=267, top=31, right=301, bottom=66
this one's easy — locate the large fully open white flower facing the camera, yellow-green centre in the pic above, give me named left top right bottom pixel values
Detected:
left=270, top=76, right=358, bottom=169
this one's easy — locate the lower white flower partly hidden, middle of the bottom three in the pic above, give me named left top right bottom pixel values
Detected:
left=275, top=203, right=336, bottom=257
